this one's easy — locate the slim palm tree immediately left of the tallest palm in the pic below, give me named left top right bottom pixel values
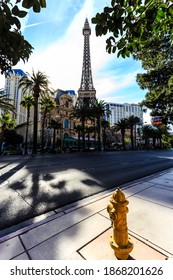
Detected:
left=20, top=95, right=34, bottom=154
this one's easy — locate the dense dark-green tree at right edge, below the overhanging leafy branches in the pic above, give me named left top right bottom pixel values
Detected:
left=134, top=36, right=173, bottom=122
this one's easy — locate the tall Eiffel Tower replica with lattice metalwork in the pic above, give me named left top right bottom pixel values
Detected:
left=78, top=18, right=96, bottom=106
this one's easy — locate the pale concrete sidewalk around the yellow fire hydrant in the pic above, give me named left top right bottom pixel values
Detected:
left=0, top=169, right=173, bottom=260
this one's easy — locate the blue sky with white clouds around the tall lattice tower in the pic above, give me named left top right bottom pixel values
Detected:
left=1, top=0, right=150, bottom=121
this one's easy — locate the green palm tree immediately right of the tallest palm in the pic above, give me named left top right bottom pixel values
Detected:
left=40, top=93, right=56, bottom=152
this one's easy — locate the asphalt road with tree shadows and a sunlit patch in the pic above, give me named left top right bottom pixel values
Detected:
left=0, top=150, right=173, bottom=236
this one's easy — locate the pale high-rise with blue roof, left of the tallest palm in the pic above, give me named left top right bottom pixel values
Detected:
left=5, top=69, right=26, bottom=125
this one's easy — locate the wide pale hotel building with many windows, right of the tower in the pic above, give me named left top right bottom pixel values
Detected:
left=107, top=103, right=143, bottom=126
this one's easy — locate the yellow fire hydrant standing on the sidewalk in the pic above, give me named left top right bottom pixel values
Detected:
left=107, top=189, right=133, bottom=260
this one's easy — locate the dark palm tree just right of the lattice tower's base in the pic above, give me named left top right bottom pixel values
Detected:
left=92, top=100, right=106, bottom=151
